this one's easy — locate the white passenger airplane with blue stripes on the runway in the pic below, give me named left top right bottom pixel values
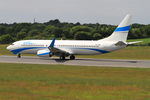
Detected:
left=7, top=14, right=141, bottom=60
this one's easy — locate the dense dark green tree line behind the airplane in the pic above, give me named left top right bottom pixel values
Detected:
left=0, top=19, right=150, bottom=44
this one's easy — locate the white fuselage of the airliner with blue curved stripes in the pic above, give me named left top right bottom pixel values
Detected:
left=7, top=40, right=126, bottom=55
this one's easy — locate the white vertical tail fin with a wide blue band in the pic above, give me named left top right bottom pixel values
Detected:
left=104, top=15, right=131, bottom=42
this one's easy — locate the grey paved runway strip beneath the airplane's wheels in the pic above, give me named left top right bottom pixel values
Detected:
left=0, top=56, right=150, bottom=68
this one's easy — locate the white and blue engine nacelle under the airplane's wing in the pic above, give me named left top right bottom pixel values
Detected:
left=37, top=49, right=53, bottom=57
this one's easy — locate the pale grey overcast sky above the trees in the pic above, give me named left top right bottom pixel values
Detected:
left=0, top=0, right=150, bottom=25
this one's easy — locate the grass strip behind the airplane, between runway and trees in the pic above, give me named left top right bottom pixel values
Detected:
left=0, top=45, right=150, bottom=60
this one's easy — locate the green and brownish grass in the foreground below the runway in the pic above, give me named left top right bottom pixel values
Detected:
left=0, top=63, right=150, bottom=100
